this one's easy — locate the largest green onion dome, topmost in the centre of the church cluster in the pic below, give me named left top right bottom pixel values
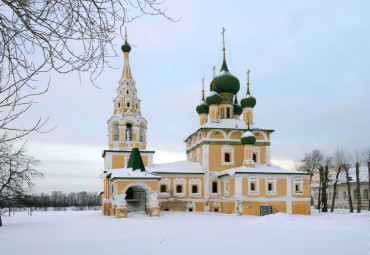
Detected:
left=210, top=60, right=240, bottom=95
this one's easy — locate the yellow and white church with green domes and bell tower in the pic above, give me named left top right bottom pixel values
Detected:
left=102, top=30, right=311, bottom=218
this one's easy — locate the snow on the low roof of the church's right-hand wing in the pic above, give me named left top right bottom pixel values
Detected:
left=218, top=164, right=308, bottom=176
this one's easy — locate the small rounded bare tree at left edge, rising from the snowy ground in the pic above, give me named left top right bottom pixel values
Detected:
left=0, top=142, right=43, bottom=226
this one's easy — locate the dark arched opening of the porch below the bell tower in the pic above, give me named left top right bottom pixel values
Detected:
left=126, top=185, right=150, bottom=212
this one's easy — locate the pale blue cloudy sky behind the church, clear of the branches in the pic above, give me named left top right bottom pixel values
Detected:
left=24, top=0, right=370, bottom=192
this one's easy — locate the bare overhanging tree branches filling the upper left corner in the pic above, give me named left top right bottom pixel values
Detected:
left=0, top=0, right=178, bottom=141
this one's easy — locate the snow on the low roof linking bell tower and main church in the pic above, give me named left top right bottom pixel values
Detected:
left=146, top=160, right=204, bottom=174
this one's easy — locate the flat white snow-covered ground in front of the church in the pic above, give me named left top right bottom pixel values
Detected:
left=0, top=210, right=370, bottom=255
